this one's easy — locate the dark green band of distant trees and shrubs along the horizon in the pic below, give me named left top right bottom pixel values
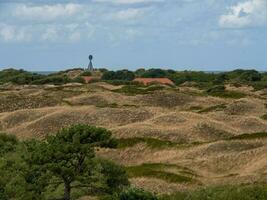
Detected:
left=0, top=68, right=267, bottom=90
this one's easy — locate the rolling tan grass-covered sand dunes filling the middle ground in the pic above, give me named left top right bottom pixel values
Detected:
left=0, top=83, right=267, bottom=192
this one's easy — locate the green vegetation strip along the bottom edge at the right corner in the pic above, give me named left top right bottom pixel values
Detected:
left=159, top=184, right=267, bottom=200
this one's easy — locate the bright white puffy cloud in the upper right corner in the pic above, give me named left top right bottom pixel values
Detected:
left=219, top=0, right=267, bottom=28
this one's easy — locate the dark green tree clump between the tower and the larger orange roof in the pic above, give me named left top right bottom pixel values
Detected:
left=102, top=70, right=135, bottom=81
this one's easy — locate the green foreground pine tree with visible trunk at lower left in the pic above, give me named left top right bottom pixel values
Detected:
left=27, top=125, right=117, bottom=200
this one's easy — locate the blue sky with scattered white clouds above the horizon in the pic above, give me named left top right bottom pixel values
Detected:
left=0, top=0, right=267, bottom=71
